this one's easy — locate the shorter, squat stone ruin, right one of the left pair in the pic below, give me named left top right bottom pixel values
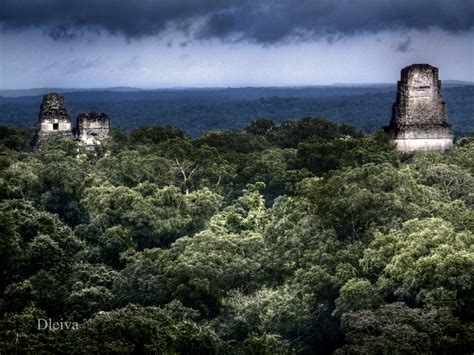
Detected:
left=76, top=112, right=110, bottom=146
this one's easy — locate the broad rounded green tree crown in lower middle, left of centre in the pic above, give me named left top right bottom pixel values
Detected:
left=156, top=231, right=265, bottom=312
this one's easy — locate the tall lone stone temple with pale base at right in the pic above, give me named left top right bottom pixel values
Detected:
left=385, top=64, right=453, bottom=155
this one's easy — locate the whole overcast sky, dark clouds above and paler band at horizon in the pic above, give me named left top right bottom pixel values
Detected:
left=0, top=0, right=474, bottom=89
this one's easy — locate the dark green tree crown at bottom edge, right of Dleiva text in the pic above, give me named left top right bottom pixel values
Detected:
left=71, top=302, right=226, bottom=354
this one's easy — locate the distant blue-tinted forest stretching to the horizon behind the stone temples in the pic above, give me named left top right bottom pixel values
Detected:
left=0, top=85, right=474, bottom=138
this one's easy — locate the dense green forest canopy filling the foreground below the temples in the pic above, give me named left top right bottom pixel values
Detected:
left=0, top=117, right=474, bottom=354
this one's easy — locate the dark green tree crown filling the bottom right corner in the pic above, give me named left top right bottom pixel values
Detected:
left=336, top=302, right=474, bottom=354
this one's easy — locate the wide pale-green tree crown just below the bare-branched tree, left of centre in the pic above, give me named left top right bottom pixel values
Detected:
left=82, top=182, right=221, bottom=253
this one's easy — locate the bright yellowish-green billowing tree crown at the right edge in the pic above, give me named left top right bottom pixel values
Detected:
left=361, top=218, right=474, bottom=318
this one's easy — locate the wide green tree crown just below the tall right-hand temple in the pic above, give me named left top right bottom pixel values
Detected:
left=300, top=163, right=438, bottom=239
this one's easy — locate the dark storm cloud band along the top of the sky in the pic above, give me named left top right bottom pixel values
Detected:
left=0, top=0, right=474, bottom=43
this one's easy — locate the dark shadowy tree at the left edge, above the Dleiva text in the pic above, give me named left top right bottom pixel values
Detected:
left=0, top=200, right=84, bottom=315
